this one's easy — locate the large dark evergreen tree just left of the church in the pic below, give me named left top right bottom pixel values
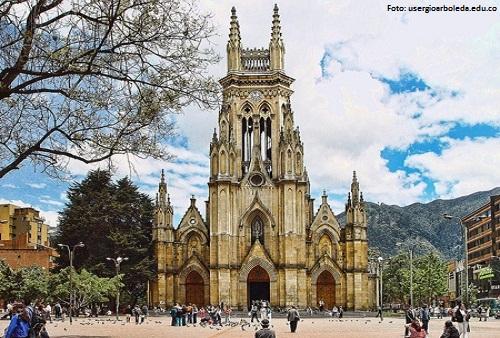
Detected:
left=55, top=170, right=156, bottom=303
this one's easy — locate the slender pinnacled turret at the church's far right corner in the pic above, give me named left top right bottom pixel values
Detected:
left=345, top=172, right=370, bottom=309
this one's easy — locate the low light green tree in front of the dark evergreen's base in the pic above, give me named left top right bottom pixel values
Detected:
left=50, top=268, right=123, bottom=309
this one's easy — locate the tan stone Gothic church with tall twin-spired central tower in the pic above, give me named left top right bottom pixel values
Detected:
left=151, top=6, right=372, bottom=309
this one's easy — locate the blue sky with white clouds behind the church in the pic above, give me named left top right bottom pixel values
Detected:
left=0, top=0, right=500, bottom=225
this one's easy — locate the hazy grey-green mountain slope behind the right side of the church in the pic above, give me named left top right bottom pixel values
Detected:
left=338, top=187, right=500, bottom=259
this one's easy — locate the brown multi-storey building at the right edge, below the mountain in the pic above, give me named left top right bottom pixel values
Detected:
left=462, top=195, right=500, bottom=297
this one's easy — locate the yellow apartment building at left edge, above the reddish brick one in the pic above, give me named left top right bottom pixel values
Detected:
left=0, top=204, right=49, bottom=246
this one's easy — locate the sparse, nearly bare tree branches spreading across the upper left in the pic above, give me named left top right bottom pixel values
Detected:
left=0, top=0, right=218, bottom=179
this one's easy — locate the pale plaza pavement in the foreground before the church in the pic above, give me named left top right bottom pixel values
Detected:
left=4, top=317, right=500, bottom=338
